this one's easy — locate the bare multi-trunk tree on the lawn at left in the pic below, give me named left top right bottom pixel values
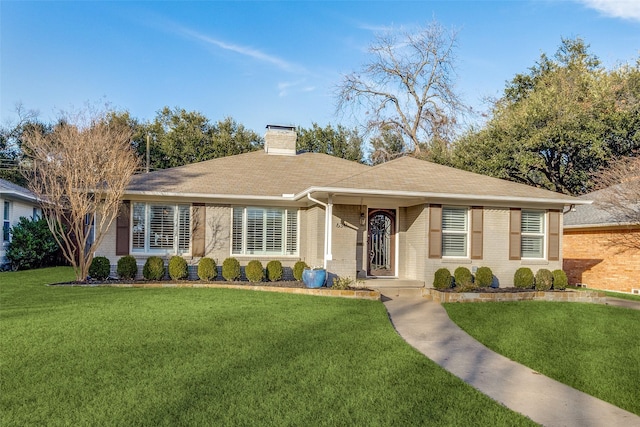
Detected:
left=23, top=107, right=138, bottom=281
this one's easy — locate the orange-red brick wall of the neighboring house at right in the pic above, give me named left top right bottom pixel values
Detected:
left=563, top=227, right=640, bottom=292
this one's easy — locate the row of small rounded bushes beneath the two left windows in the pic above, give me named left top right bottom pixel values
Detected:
left=94, top=255, right=308, bottom=282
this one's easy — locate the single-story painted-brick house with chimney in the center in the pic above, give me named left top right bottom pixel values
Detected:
left=96, top=126, right=588, bottom=286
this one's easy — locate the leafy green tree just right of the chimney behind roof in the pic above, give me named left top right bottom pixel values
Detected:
left=296, top=122, right=364, bottom=163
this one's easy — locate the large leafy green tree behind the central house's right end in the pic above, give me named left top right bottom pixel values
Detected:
left=450, top=38, right=639, bottom=194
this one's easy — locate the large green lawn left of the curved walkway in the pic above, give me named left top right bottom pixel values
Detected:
left=0, top=268, right=533, bottom=426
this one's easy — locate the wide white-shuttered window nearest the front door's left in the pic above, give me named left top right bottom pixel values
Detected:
left=231, top=207, right=298, bottom=255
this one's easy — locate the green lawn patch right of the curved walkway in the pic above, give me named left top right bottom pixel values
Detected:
left=444, top=301, right=640, bottom=415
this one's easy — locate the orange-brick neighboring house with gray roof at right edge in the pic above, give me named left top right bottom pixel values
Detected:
left=564, top=188, right=640, bottom=294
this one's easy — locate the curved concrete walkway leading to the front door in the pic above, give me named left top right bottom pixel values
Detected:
left=383, top=297, right=640, bottom=427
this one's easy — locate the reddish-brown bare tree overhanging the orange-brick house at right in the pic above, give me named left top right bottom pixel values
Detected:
left=594, top=157, right=640, bottom=249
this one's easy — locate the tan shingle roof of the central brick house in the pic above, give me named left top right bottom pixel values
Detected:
left=128, top=151, right=579, bottom=203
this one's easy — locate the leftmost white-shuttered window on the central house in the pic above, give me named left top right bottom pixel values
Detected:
left=131, top=202, right=191, bottom=255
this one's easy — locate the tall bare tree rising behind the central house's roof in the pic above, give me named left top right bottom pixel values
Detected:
left=337, top=21, right=463, bottom=155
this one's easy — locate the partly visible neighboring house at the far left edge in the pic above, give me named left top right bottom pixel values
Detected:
left=0, top=178, right=42, bottom=267
